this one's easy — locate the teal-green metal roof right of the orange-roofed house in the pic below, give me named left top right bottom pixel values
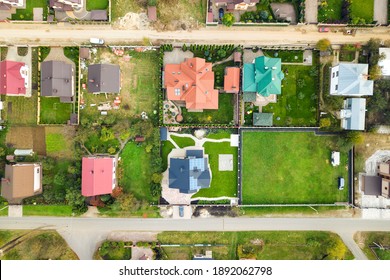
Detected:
left=242, top=56, right=284, bottom=97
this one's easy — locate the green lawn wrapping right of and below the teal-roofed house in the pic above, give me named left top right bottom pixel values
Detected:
left=263, top=65, right=318, bottom=126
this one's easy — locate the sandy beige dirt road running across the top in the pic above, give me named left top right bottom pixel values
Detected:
left=0, top=23, right=390, bottom=46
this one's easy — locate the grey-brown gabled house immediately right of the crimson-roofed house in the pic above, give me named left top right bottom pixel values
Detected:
left=41, top=60, right=74, bottom=103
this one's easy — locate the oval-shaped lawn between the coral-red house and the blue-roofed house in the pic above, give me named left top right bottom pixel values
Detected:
left=119, top=142, right=154, bottom=201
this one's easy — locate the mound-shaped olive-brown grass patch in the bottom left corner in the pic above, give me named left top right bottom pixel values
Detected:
left=1, top=231, right=78, bottom=260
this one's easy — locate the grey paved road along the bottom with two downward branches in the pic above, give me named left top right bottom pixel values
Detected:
left=0, top=217, right=390, bottom=259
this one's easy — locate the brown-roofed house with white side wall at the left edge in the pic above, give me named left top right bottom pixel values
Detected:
left=1, top=163, right=42, bottom=204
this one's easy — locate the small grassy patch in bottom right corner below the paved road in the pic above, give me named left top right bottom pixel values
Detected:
left=354, top=231, right=390, bottom=260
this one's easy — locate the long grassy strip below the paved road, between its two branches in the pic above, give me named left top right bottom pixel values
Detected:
left=157, top=231, right=353, bottom=260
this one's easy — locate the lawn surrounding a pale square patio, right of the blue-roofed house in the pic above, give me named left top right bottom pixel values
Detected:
left=193, top=142, right=238, bottom=198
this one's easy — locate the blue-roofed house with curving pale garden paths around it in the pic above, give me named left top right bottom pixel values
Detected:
left=168, top=149, right=211, bottom=194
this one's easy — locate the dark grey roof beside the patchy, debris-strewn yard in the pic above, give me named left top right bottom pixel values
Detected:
left=88, top=64, right=120, bottom=93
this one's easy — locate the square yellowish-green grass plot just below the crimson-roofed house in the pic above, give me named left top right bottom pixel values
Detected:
left=1, top=94, right=38, bottom=125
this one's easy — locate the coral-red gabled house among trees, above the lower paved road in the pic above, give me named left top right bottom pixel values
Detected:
left=81, top=156, right=117, bottom=197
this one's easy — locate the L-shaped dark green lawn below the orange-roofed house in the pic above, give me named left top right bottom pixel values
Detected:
left=182, top=93, right=235, bottom=124
